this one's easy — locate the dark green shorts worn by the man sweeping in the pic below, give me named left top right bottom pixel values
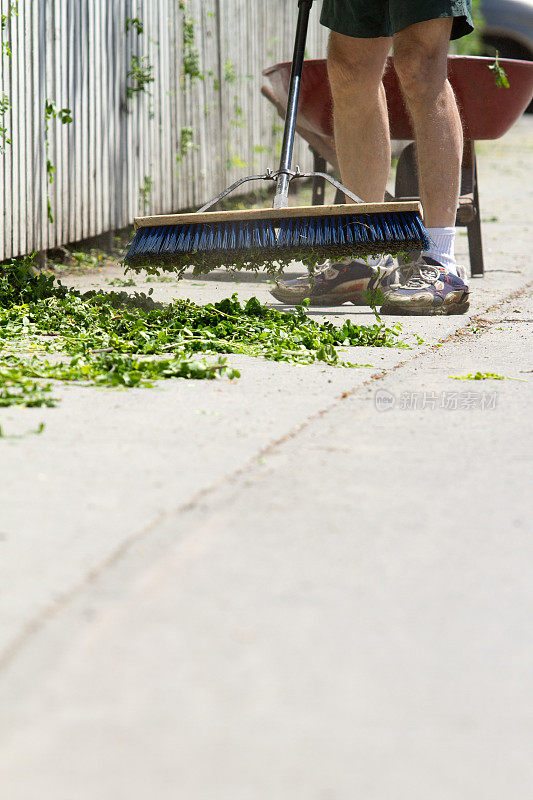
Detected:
left=320, top=0, right=474, bottom=39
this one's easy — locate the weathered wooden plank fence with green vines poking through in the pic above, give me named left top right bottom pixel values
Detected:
left=0, top=0, right=327, bottom=261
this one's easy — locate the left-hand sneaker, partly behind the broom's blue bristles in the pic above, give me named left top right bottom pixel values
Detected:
left=270, top=256, right=394, bottom=306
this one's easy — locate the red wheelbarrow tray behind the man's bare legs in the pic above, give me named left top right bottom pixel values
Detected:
left=263, top=56, right=533, bottom=164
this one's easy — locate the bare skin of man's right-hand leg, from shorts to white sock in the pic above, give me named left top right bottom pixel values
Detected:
left=394, top=18, right=463, bottom=228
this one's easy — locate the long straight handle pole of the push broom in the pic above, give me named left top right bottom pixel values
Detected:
left=274, top=0, right=313, bottom=208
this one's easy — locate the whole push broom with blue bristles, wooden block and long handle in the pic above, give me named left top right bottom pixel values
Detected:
left=125, top=0, right=429, bottom=273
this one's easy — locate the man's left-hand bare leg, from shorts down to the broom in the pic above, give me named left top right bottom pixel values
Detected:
left=328, top=32, right=392, bottom=203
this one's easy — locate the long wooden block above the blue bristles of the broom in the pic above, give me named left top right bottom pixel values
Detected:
left=133, top=200, right=422, bottom=230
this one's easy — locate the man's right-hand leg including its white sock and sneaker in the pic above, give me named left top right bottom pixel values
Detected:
left=381, top=18, right=469, bottom=314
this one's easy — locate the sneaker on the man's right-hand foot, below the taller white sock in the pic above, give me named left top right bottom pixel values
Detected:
left=380, top=256, right=470, bottom=315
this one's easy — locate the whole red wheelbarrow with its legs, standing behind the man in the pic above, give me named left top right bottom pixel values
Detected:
left=261, top=56, right=533, bottom=275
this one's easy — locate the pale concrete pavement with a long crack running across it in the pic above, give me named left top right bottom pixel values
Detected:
left=0, top=118, right=533, bottom=800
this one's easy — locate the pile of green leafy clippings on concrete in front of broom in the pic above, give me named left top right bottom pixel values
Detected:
left=0, top=259, right=405, bottom=406
